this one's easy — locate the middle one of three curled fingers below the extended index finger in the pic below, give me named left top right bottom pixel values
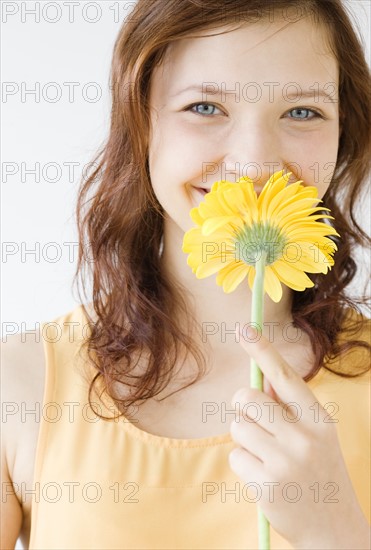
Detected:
left=231, top=418, right=275, bottom=462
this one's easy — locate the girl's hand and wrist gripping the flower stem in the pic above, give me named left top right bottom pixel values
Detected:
left=229, top=329, right=370, bottom=550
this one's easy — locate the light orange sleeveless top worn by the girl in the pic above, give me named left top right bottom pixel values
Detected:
left=30, top=307, right=370, bottom=550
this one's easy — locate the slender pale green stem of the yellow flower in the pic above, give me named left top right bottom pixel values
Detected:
left=250, top=251, right=270, bottom=550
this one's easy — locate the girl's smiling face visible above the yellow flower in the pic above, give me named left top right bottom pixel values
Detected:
left=149, top=16, right=339, bottom=232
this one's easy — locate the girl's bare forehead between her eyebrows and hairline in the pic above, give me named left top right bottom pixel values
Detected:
left=153, top=18, right=338, bottom=95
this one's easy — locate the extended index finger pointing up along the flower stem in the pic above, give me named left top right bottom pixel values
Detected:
left=240, top=327, right=317, bottom=418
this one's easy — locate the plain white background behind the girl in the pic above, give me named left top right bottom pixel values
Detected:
left=1, top=0, right=370, bottom=340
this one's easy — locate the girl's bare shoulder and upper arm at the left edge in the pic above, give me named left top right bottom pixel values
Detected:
left=0, top=332, right=45, bottom=549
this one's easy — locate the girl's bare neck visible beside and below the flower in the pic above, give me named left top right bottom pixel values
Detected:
left=162, top=218, right=292, bottom=356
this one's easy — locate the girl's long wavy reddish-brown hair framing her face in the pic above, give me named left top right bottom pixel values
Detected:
left=75, top=0, right=371, bottom=420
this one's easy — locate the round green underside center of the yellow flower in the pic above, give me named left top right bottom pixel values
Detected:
left=235, top=222, right=288, bottom=265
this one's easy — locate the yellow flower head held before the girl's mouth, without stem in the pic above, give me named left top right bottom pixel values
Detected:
left=182, top=171, right=339, bottom=302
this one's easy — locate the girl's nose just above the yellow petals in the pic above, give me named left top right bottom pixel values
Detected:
left=223, top=123, right=289, bottom=187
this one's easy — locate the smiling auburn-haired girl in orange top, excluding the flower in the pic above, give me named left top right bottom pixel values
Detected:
left=2, top=0, right=370, bottom=549
